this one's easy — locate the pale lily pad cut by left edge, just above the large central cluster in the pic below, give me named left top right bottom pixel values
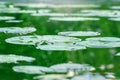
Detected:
left=0, top=27, right=36, bottom=34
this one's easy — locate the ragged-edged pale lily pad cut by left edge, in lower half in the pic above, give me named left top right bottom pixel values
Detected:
left=0, top=54, right=35, bottom=63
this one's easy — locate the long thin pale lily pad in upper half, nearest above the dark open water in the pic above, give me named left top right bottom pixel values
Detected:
left=49, top=17, right=99, bottom=21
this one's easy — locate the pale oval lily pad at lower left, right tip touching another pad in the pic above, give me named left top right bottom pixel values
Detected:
left=13, top=66, right=53, bottom=74
